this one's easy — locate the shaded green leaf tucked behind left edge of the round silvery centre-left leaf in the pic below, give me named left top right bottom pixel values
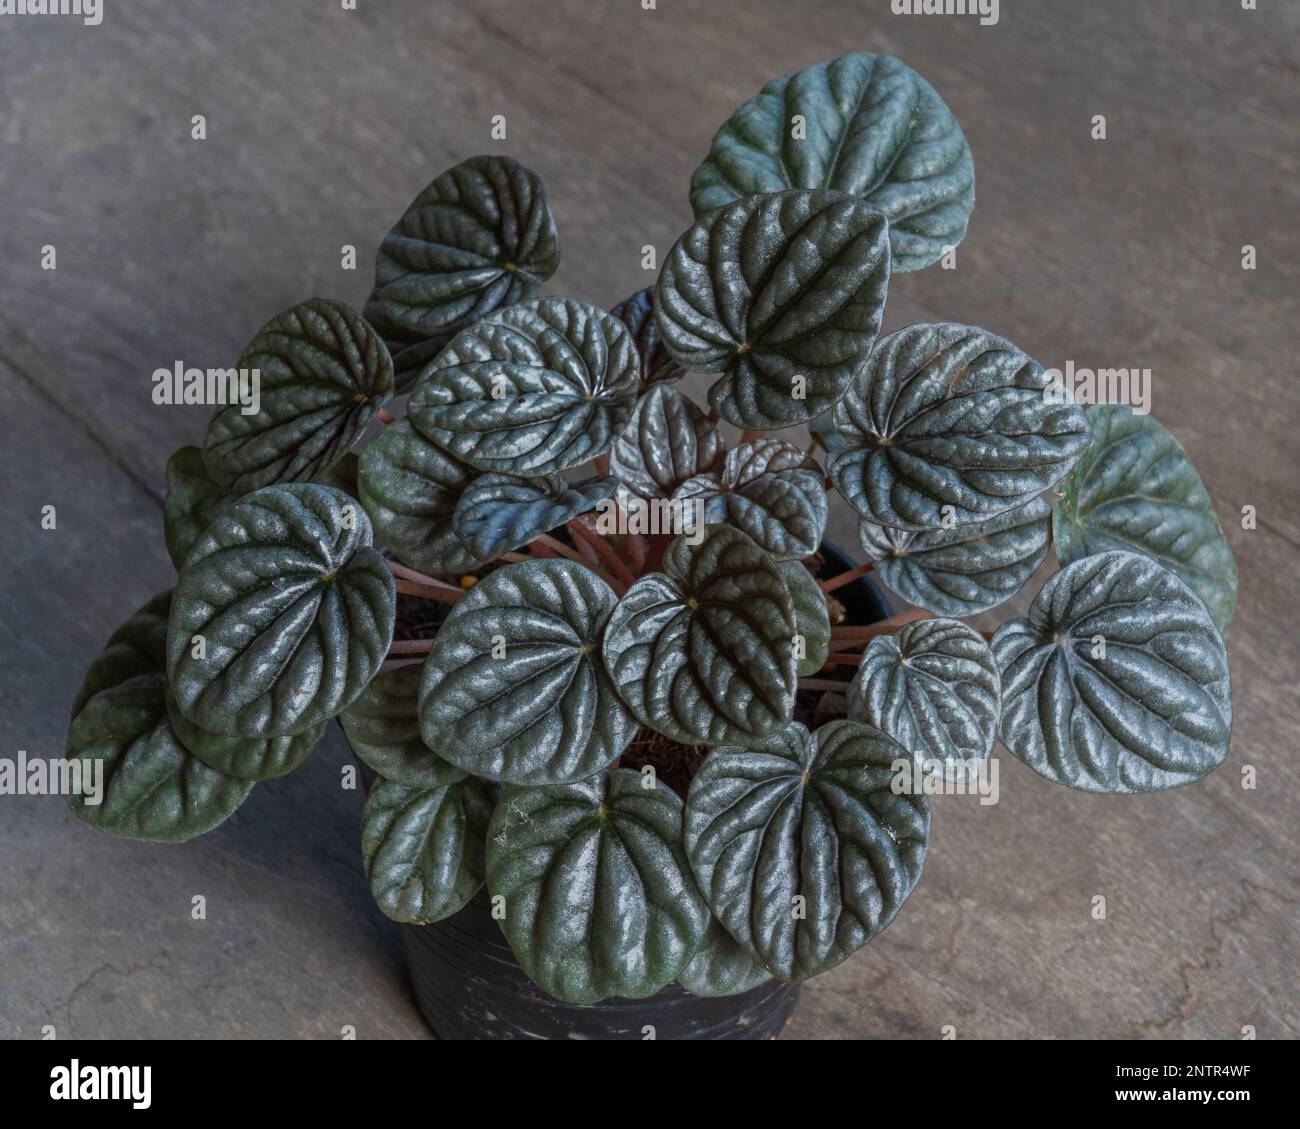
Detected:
left=338, top=663, right=465, bottom=790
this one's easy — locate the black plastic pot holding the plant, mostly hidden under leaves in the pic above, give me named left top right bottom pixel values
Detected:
left=400, top=544, right=893, bottom=1039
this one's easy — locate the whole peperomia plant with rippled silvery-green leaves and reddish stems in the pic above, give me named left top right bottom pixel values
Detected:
left=68, top=53, right=1236, bottom=1004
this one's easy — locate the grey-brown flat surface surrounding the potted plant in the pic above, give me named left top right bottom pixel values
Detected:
left=0, top=0, right=1300, bottom=1038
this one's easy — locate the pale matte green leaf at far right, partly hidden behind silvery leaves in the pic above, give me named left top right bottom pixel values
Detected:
left=1052, top=405, right=1236, bottom=631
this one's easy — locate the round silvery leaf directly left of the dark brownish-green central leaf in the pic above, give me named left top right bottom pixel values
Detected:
left=420, top=559, right=637, bottom=784
